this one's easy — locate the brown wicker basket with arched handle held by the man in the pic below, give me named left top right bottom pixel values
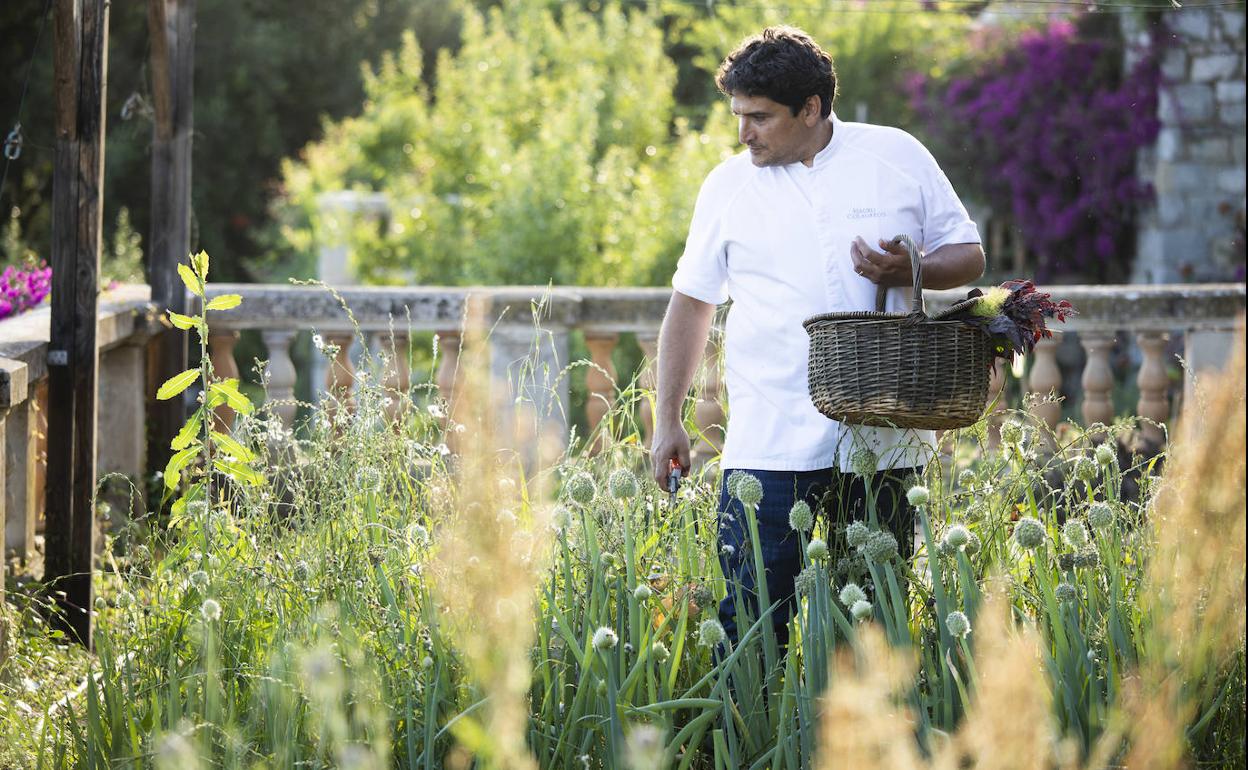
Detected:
left=802, top=236, right=992, bottom=429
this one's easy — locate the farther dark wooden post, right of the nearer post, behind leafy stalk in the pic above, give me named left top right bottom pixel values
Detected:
left=147, top=0, right=195, bottom=484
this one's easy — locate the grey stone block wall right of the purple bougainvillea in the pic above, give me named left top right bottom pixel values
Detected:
left=1124, top=7, right=1244, bottom=283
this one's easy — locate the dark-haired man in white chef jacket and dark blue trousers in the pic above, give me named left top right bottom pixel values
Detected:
left=651, top=27, right=985, bottom=641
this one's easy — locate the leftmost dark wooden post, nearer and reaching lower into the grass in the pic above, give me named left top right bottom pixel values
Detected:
left=45, top=0, right=109, bottom=646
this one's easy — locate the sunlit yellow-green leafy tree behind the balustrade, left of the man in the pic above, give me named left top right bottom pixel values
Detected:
left=280, top=2, right=733, bottom=286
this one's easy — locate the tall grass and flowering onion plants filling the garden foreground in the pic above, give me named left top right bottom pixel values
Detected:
left=7, top=273, right=1244, bottom=770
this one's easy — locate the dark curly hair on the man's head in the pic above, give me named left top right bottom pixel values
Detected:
left=715, top=26, right=836, bottom=117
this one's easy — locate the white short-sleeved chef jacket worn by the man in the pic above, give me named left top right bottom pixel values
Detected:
left=671, top=112, right=980, bottom=470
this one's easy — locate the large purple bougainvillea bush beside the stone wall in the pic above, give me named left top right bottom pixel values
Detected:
left=910, top=21, right=1159, bottom=281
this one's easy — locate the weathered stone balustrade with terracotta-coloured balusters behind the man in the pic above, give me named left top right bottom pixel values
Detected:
left=0, top=285, right=1244, bottom=576
